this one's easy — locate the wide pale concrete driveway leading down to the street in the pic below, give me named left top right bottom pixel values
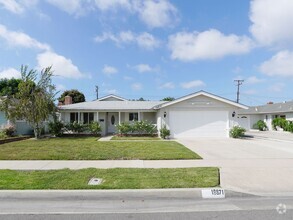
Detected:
left=178, top=136, right=293, bottom=195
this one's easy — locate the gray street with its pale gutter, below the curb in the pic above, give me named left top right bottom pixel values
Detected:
left=0, top=191, right=293, bottom=220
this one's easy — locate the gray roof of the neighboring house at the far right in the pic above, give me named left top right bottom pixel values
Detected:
left=239, top=101, right=293, bottom=115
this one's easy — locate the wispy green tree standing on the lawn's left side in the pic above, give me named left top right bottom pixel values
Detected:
left=1, top=66, right=56, bottom=139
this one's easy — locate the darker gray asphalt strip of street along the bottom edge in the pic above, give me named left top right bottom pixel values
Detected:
left=0, top=210, right=292, bottom=220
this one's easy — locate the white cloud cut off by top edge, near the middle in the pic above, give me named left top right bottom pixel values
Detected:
left=134, top=0, right=178, bottom=28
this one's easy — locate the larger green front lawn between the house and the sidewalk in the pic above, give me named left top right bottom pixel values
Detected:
left=0, top=137, right=201, bottom=160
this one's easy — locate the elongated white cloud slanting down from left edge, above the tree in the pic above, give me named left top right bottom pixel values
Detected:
left=0, top=24, right=50, bottom=50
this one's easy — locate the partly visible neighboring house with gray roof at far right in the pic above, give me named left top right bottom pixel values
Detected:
left=237, top=101, right=293, bottom=130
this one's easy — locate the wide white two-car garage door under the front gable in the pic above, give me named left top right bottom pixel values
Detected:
left=169, top=111, right=228, bottom=138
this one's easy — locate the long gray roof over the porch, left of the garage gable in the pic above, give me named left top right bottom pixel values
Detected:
left=59, top=100, right=165, bottom=111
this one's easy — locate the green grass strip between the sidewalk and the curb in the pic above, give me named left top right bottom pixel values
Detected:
left=0, top=167, right=220, bottom=189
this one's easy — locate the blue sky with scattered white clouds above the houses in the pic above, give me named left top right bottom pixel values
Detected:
left=0, top=0, right=293, bottom=105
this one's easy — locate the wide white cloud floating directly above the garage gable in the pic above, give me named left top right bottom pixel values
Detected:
left=168, top=29, right=253, bottom=61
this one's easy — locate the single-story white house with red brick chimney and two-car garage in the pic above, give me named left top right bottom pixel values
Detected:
left=59, top=91, right=248, bottom=138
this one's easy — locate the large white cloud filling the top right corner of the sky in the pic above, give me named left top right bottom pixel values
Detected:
left=250, top=0, right=293, bottom=46
